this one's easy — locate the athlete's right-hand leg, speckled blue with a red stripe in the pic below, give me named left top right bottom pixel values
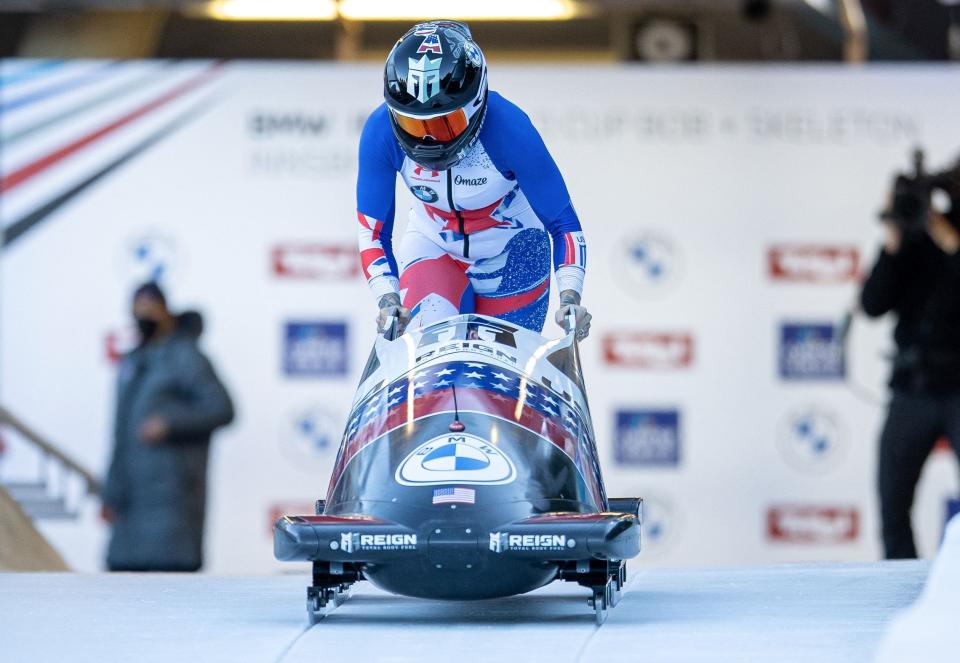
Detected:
left=467, top=228, right=550, bottom=332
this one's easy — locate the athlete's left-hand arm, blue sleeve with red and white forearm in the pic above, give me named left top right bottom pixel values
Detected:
left=357, top=105, right=403, bottom=300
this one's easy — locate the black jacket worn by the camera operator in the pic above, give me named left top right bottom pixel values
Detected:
left=860, top=233, right=960, bottom=393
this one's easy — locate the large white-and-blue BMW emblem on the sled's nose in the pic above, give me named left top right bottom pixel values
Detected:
left=396, top=433, right=517, bottom=486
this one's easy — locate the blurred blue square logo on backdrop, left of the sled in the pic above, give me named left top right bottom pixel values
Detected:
left=283, top=322, right=348, bottom=377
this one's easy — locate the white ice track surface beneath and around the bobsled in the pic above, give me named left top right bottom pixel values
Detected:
left=0, top=562, right=928, bottom=663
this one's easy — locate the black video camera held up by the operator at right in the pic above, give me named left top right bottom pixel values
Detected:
left=880, top=148, right=960, bottom=232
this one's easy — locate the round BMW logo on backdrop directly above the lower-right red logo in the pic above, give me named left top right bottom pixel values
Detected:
left=777, top=405, right=845, bottom=474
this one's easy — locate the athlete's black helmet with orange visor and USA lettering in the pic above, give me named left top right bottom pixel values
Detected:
left=383, top=21, right=487, bottom=170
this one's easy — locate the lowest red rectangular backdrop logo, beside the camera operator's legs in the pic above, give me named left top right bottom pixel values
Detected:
left=767, top=505, right=860, bottom=545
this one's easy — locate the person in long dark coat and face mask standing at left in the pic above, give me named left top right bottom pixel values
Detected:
left=103, top=283, right=234, bottom=571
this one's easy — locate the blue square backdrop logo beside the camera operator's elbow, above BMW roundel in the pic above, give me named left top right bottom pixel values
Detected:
left=779, top=322, right=846, bottom=380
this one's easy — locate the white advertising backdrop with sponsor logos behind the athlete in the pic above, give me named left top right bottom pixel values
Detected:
left=0, top=60, right=960, bottom=573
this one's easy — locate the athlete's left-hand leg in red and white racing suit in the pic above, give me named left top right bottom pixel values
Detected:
left=397, top=230, right=473, bottom=329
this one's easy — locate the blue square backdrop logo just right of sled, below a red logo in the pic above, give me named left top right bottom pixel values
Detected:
left=614, top=410, right=680, bottom=467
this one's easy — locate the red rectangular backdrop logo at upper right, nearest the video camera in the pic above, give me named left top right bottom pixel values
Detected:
left=767, top=244, right=860, bottom=284
